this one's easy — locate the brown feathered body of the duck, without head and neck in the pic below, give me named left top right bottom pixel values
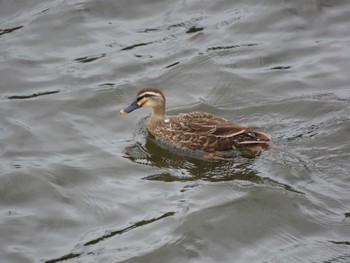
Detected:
left=154, top=112, right=271, bottom=151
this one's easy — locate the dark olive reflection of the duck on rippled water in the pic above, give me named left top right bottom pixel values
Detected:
left=124, top=125, right=300, bottom=194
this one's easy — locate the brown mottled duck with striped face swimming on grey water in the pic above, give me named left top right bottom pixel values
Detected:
left=119, top=87, right=271, bottom=153
